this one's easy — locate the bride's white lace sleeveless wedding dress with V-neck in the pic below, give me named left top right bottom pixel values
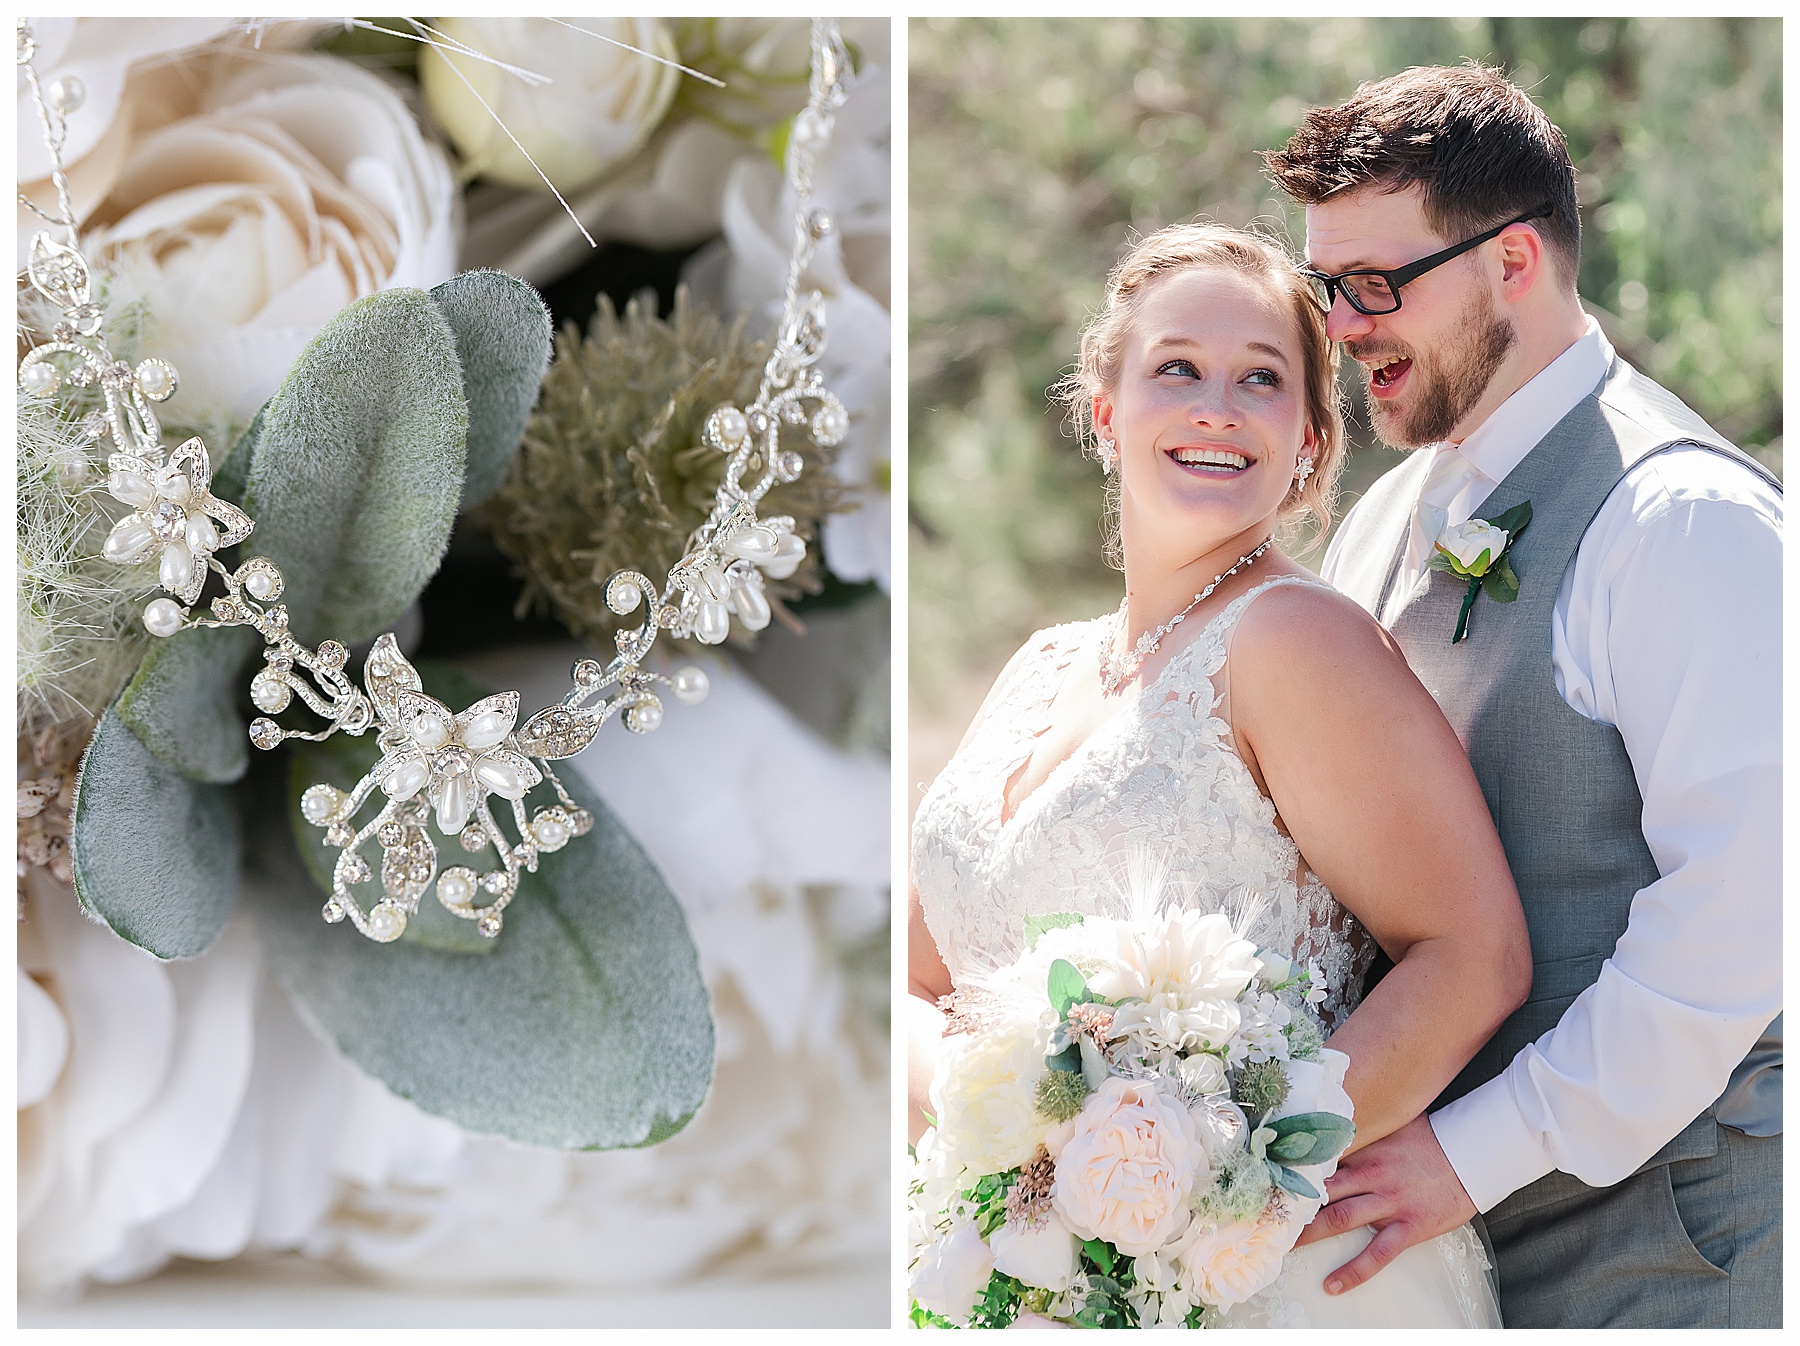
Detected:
left=913, top=576, right=1499, bottom=1328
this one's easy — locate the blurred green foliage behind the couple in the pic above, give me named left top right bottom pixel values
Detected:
left=909, top=18, right=1782, bottom=730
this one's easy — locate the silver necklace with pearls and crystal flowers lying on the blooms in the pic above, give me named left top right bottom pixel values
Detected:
left=18, top=18, right=850, bottom=943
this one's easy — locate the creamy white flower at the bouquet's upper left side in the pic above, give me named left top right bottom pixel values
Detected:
left=931, top=1020, right=1049, bottom=1173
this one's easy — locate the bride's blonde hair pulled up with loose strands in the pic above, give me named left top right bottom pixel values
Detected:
left=1051, top=223, right=1345, bottom=565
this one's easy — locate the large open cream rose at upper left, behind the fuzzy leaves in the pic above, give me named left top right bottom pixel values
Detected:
left=74, top=49, right=457, bottom=425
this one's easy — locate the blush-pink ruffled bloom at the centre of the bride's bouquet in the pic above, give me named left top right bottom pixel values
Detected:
left=1051, top=1076, right=1206, bottom=1258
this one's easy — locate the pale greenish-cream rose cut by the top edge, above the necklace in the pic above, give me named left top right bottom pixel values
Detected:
left=419, top=16, right=682, bottom=196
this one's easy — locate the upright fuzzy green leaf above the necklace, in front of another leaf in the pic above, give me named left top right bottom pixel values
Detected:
left=245, top=290, right=468, bottom=644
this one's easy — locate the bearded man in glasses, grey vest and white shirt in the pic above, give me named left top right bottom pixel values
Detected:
left=1267, top=65, right=1782, bottom=1326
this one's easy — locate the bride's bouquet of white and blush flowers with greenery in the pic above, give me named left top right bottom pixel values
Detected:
left=909, top=911, right=1355, bottom=1328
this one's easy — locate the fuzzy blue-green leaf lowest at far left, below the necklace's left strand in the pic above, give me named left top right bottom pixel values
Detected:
left=68, top=711, right=238, bottom=959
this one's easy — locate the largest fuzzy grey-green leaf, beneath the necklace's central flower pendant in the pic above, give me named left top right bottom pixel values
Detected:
left=248, top=666, right=713, bottom=1150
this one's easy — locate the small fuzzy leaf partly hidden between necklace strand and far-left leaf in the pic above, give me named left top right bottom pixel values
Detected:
left=113, top=626, right=261, bottom=783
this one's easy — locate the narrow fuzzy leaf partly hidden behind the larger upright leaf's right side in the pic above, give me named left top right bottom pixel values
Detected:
left=432, top=272, right=551, bottom=509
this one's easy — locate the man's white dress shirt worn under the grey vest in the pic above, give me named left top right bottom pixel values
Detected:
left=1323, top=319, right=1782, bottom=1211
